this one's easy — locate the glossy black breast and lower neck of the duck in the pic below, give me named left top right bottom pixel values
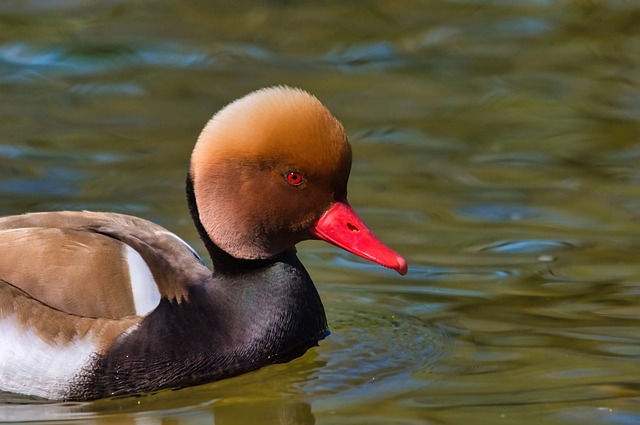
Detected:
left=68, top=252, right=328, bottom=399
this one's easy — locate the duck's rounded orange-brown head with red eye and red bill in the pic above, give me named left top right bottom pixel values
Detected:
left=190, top=87, right=407, bottom=274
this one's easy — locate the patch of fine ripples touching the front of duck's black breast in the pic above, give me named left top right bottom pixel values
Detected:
left=306, top=308, right=452, bottom=406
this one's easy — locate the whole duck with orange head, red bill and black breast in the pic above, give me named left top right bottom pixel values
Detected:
left=0, top=86, right=407, bottom=401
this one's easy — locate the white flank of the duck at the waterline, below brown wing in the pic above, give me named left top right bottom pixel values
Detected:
left=0, top=317, right=96, bottom=399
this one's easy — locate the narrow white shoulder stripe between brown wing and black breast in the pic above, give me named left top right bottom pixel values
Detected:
left=127, top=245, right=160, bottom=316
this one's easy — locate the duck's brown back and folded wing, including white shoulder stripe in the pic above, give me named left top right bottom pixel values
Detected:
left=0, top=211, right=210, bottom=319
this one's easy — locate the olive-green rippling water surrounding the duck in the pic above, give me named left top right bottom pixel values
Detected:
left=0, top=0, right=640, bottom=425
